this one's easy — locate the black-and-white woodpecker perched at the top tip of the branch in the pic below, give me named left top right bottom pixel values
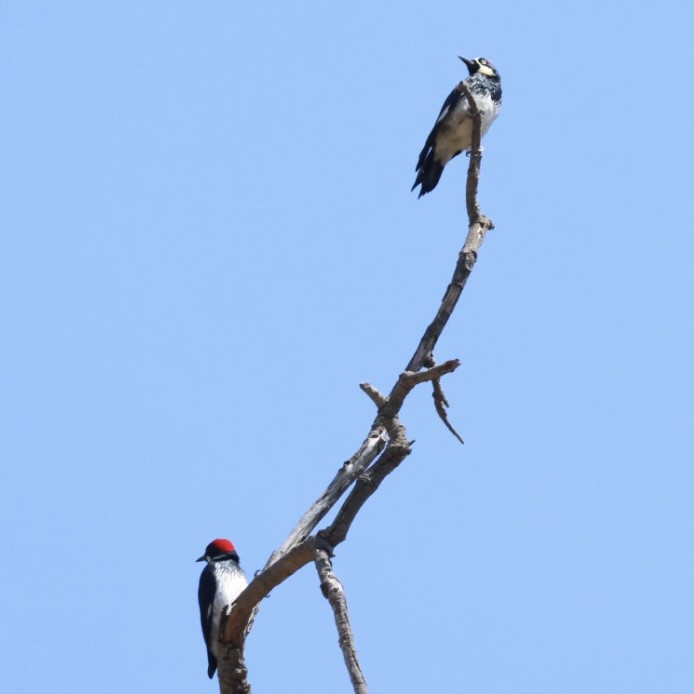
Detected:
left=412, top=56, right=501, bottom=198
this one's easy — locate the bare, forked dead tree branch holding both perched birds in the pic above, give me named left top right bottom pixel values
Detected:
left=218, top=82, right=494, bottom=694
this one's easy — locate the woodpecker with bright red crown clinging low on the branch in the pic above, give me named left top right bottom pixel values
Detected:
left=195, top=539, right=248, bottom=679
